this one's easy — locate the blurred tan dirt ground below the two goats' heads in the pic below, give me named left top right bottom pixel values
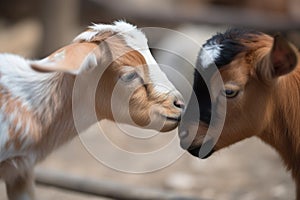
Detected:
left=38, top=122, right=294, bottom=200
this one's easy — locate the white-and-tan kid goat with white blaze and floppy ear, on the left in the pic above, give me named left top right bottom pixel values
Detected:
left=0, top=21, right=184, bottom=200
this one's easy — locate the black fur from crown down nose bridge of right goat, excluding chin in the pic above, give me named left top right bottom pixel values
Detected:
left=191, top=28, right=261, bottom=124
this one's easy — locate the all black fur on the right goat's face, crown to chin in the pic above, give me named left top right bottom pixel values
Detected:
left=179, top=28, right=261, bottom=158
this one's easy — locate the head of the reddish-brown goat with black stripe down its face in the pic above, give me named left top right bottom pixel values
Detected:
left=179, top=29, right=298, bottom=158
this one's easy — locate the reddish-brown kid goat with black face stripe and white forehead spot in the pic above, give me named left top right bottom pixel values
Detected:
left=179, top=29, right=300, bottom=200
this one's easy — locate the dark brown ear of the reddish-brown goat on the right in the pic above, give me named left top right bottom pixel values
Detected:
left=270, top=35, right=298, bottom=77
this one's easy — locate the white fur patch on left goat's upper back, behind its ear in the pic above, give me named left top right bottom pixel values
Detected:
left=0, top=54, right=56, bottom=110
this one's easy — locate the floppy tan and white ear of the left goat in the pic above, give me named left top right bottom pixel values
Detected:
left=30, top=42, right=100, bottom=74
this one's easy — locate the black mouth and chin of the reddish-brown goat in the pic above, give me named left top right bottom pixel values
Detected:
left=187, top=139, right=215, bottom=159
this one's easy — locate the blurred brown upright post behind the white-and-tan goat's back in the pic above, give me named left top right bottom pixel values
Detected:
left=38, top=0, right=80, bottom=57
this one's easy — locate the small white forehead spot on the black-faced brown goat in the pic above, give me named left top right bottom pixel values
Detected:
left=199, top=44, right=222, bottom=69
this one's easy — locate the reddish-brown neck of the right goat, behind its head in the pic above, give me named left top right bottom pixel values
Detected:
left=259, top=66, right=300, bottom=197
